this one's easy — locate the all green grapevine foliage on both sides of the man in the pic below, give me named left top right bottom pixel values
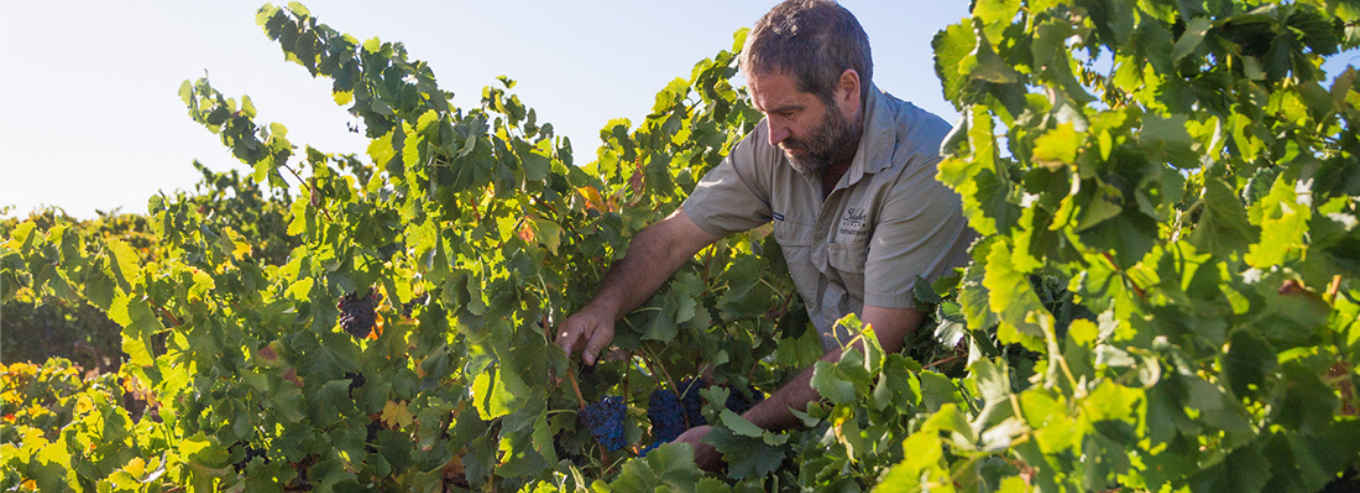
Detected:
left=0, top=0, right=1360, bottom=492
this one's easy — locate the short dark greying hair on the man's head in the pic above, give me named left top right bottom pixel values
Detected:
left=740, top=0, right=873, bottom=105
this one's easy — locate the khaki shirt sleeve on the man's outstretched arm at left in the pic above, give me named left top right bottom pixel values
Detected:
left=681, top=121, right=771, bottom=236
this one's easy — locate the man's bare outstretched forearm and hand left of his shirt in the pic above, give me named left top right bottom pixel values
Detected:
left=555, top=208, right=719, bottom=365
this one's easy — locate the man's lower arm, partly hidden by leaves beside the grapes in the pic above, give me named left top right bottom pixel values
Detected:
left=676, top=306, right=922, bottom=470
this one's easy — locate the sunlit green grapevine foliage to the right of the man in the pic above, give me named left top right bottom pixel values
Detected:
left=885, top=0, right=1360, bottom=492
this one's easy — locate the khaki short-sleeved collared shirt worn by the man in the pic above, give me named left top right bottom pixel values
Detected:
left=684, top=87, right=975, bottom=351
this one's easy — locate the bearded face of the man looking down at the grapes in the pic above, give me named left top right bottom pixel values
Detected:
left=748, top=74, right=862, bottom=176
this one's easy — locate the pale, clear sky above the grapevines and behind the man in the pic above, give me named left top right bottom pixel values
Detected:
left=0, top=0, right=967, bottom=218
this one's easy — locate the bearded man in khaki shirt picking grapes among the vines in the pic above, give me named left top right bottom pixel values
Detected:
left=556, top=0, right=974, bottom=468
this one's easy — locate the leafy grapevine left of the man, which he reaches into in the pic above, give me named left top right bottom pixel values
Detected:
left=0, top=4, right=815, bottom=490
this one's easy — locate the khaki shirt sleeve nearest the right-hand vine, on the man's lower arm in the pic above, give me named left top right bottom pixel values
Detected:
left=864, top=155, right=975, bottom=308
